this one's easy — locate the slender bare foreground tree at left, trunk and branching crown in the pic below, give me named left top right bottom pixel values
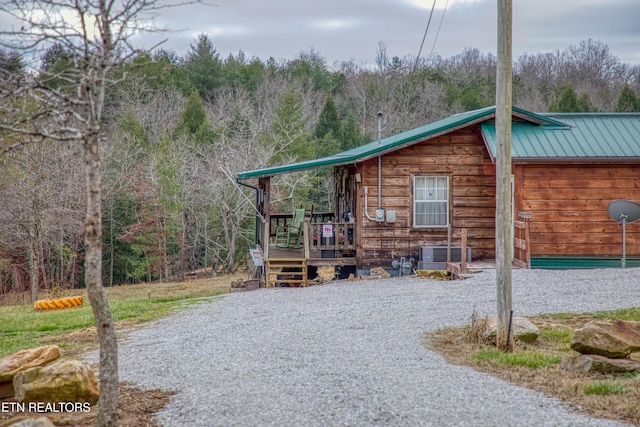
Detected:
left=0, top=0, right=201, bottom=426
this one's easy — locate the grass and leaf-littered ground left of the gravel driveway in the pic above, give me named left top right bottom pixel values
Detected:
left=0, top=276, right=238, bottom=427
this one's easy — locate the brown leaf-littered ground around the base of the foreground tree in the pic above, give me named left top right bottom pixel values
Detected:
left=0, top=383, right=173, bottom=427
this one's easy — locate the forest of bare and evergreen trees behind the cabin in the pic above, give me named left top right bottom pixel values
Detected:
left=0, top=35, right=640, bottom=294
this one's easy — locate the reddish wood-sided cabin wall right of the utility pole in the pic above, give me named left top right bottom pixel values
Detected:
left=514, top=164, right=640, bottom=257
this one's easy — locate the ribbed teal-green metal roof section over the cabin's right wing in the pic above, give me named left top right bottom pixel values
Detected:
left=481, top=113, right=640, bottom=160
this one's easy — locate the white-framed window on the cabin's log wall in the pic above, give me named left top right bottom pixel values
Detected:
left=413, top=176, right=449, bottom=227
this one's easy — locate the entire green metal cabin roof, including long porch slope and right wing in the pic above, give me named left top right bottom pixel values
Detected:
left=237, top=106, right=640, bottom=179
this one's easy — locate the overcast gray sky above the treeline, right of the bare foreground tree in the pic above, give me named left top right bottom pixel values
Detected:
left=136, top=0, right=640, bottom=65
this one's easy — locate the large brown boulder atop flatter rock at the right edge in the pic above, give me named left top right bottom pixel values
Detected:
left=571, top=320, right=640, bottom=359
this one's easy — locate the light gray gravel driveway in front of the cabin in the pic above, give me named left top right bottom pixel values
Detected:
left=110, top=269, right=640, bottom=427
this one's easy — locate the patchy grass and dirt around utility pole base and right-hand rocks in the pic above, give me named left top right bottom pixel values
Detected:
left=425, top=315, right=640, bottom=426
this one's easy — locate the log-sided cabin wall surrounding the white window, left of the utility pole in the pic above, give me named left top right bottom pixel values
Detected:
left=356, top=126, right=495, bottom=268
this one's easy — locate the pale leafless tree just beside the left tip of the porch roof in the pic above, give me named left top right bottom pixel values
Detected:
left=200, top=88, right=270, bottom=274
